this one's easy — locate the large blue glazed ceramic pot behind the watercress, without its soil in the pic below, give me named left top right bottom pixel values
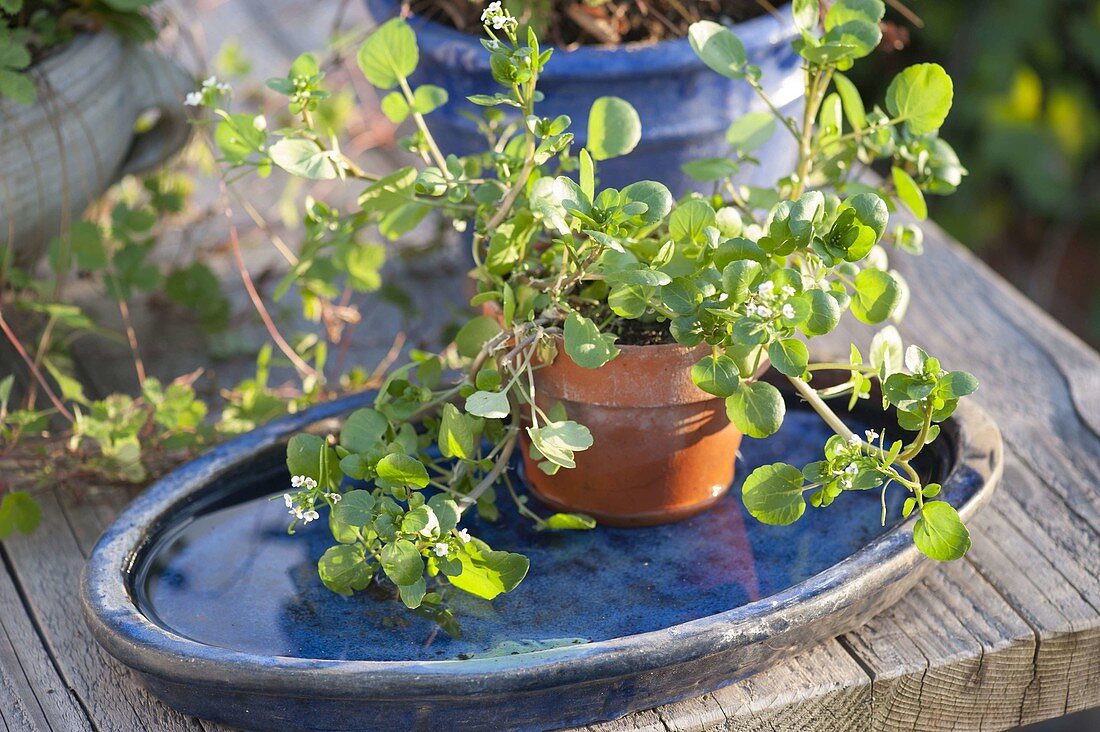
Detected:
left=366, top=0, right=803, bottom=196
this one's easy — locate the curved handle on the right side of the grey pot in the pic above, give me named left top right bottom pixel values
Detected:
left=114, top=45, right=195, bottom=179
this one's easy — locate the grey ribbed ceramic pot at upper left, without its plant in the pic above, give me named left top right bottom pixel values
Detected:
left=0, top=33, right=194, bottom=265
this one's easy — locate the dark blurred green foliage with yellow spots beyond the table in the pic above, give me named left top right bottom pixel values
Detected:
left=856, top=0, right=1100, bottom=343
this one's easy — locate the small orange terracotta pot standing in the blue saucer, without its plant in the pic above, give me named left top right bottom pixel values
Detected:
left=523, top=342, right=741, bottom=526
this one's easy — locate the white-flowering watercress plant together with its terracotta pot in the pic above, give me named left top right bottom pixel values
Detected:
left=204, top=0, right=977, bottom=627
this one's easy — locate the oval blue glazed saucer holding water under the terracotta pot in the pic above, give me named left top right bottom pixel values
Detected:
left=83, top=385, right=1001, bottom=730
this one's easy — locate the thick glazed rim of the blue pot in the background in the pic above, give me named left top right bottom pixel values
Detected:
left=366, top=0, right=798, bottom=79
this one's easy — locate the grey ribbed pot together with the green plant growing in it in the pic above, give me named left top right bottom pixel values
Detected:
left=0, top=0, right=193, bottom=264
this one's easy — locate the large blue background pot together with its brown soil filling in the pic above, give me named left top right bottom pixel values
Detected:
left=367, top=0, right=803, bottom=196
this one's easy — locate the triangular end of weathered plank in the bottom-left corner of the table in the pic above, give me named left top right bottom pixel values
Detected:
left=0, top=550, right=91, bottom=732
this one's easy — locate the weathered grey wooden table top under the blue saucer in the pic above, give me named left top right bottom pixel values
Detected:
left=0, top=210, right=1100, bottom=732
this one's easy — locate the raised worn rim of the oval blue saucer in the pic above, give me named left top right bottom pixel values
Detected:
left=80, top=383, right=1003, bottom=700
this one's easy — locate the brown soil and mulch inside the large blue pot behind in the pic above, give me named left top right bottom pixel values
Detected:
left=405, top=0, right=781, bottom=48
